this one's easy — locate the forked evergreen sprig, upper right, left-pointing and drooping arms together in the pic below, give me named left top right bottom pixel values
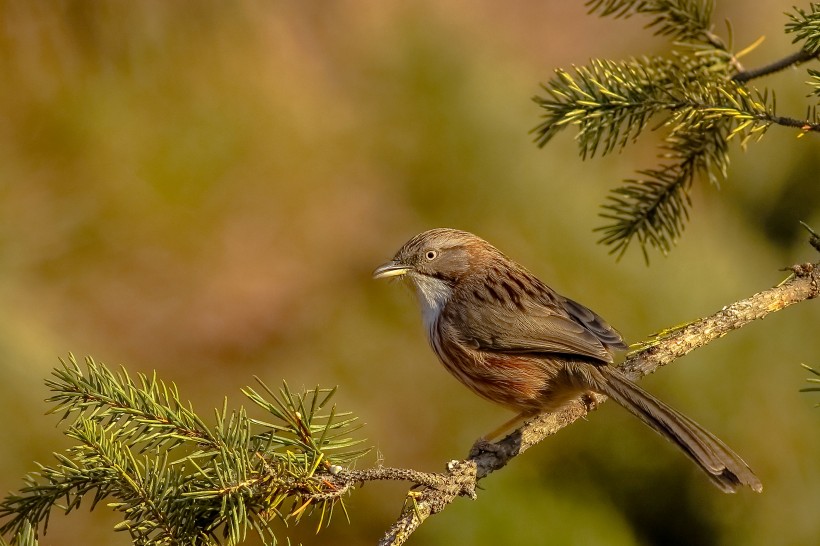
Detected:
left=535, top=55, right=777, bottom=259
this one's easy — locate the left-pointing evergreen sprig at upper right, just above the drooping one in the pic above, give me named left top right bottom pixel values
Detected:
left=533, top=55, right=776, bottom=159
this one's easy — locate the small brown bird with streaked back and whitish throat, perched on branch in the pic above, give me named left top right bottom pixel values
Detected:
left=373, top=228, right=763, bottom=493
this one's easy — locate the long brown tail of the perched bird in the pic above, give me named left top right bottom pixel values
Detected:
left=598, top=366, right=763, bottom=493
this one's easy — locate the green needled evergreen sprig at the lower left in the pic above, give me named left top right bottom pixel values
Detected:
left=0, top=356, right=368, bottom=545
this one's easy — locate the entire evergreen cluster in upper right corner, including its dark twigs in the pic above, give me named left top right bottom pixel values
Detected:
left=533, top=0, right=820, bottom=260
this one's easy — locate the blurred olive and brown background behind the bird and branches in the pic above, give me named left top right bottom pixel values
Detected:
left=0, top=0, right=820, bottom=546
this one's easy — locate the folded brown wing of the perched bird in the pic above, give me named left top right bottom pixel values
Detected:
left=454, top=276, right=626, bottom=362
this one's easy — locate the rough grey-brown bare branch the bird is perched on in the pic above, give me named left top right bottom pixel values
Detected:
left=328, top=263, right=820, bottom=546
